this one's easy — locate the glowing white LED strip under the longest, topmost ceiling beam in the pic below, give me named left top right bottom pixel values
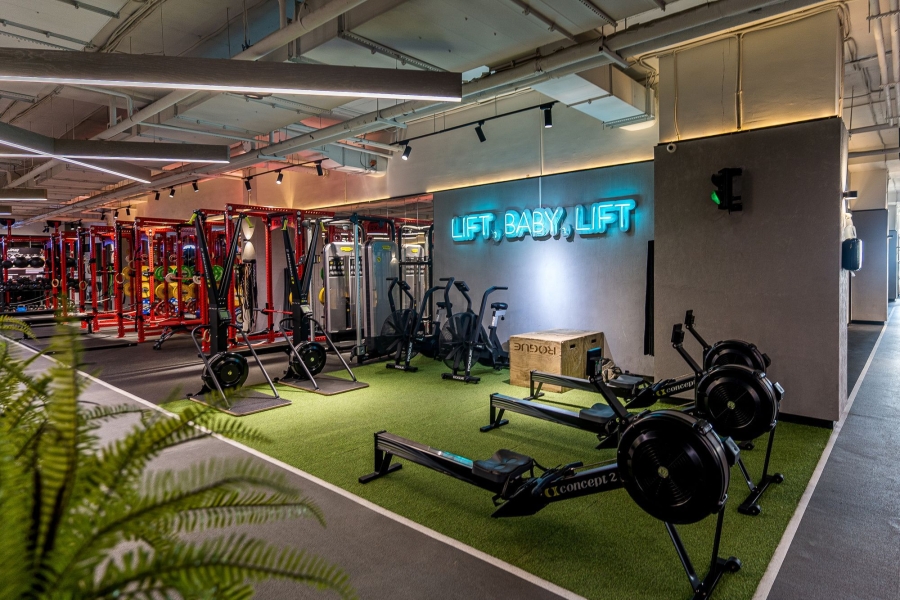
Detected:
left=0, top=75, right=460, bottom=102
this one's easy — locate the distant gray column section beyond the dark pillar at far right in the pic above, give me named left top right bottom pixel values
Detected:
left=850, top=209, right=888, bottom=323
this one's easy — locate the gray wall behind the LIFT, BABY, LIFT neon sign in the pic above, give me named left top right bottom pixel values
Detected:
left=434, top=162, right=653, bottom=373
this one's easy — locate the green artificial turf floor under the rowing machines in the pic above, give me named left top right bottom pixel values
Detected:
left=166, top=357, right=829, bottom=600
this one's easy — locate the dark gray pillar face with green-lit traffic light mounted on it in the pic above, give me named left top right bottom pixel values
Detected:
left=654, top=118, right=846, bottom=420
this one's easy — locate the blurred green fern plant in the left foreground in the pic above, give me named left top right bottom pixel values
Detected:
left=0, top=318, right=355, bottom=600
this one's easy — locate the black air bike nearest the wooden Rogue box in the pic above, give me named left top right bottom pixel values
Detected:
left=440, top=281, right=509, bottom=383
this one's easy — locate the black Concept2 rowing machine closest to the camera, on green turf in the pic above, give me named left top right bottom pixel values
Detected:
left=359, top=378, right=741, bottom=599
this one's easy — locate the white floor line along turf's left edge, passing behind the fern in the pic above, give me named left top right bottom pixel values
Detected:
left=10, top=340, right=586, bottom=600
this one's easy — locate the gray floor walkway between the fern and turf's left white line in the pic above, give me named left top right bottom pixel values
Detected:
left=10, top=349, right=574, bottom=600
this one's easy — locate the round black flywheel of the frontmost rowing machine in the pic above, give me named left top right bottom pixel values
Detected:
left=617, top=410, right=730, bottom=524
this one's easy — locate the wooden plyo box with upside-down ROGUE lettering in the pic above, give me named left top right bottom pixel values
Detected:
left=509, top=329, right=605, bottom=392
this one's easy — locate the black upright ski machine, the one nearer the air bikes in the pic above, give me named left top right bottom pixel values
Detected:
left=278, top=217, right=360, bottom=395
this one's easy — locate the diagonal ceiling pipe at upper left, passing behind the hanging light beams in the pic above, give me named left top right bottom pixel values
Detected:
left=6, top=0, right=366, bottom=187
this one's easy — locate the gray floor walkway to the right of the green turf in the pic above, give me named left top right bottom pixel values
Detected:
left=769, top=315, right=900, bottom=600
